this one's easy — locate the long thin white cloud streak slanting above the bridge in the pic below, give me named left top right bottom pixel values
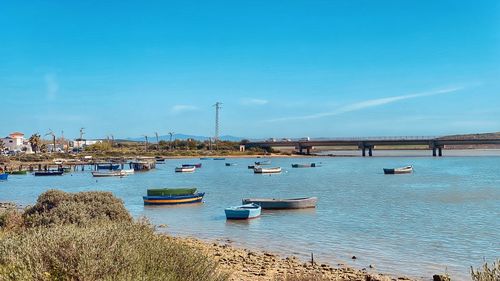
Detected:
left=269, top=87, right=464, bottom=122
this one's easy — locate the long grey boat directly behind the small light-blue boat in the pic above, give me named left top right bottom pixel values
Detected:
left=242, top=197, right=318, bottom=209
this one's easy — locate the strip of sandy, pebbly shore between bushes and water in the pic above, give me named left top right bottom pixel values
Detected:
left=166, top=236, right=411, bottom=281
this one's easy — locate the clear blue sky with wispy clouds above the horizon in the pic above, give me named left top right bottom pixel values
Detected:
left=0, top=0, right=500, bottom=138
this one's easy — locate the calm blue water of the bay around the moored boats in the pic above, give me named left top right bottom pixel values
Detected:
left=0, top=154, right=500, bottom=280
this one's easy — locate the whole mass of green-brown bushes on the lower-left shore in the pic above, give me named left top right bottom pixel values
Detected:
left=0, top=190, right=228, bottom=281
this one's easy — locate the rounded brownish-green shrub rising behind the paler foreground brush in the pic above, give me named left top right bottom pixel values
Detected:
left=23, top=190, right=132, bottom=227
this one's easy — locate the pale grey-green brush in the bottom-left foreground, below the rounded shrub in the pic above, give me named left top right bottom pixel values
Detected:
left=0, top=220, right=227, bottom=281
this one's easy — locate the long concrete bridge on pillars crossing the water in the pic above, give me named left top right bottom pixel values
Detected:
left=245, top=137, right=500, bottom=156
